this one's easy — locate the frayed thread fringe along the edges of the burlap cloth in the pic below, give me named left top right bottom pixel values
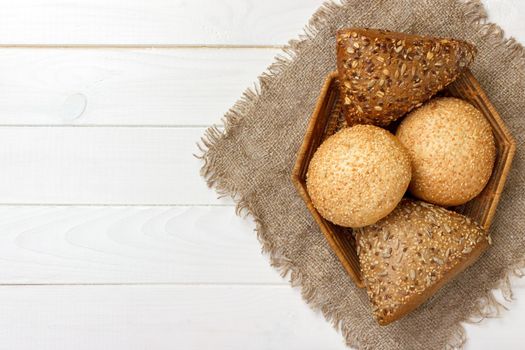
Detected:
left=197, top=0, right=525, bottom=349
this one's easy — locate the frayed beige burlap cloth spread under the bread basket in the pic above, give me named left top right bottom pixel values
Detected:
left=201, top=0, right=525, bottom=349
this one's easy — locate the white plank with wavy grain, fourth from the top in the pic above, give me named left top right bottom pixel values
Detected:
left=0, top=206, right=287, bottom=284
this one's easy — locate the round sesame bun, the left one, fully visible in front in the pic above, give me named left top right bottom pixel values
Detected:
left=306, top=125, right=411, bottom=227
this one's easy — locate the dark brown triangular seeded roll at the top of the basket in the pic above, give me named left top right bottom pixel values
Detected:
left=337, top=28, right=476, bottom=126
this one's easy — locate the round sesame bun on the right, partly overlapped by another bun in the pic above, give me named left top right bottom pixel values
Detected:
left=396, top=97, right=496, bottom=206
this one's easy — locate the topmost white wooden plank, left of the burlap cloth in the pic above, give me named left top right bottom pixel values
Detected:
left=0, top=0, right=323, bottom=45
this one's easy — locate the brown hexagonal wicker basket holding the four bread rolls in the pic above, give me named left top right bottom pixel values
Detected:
left=292, top=71, right=516, bottom=288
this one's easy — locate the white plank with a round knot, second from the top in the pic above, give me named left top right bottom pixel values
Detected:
left=0, top=48, right=280, bottom=126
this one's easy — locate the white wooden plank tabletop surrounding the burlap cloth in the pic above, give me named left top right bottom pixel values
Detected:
left=0, top=0, right=525, bottom=350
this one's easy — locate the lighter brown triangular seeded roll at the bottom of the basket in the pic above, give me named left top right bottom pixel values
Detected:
left=356, top=199, right=490, bottom=325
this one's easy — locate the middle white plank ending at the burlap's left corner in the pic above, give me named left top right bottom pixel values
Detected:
left=0, top=127, right=224, bottom=205
